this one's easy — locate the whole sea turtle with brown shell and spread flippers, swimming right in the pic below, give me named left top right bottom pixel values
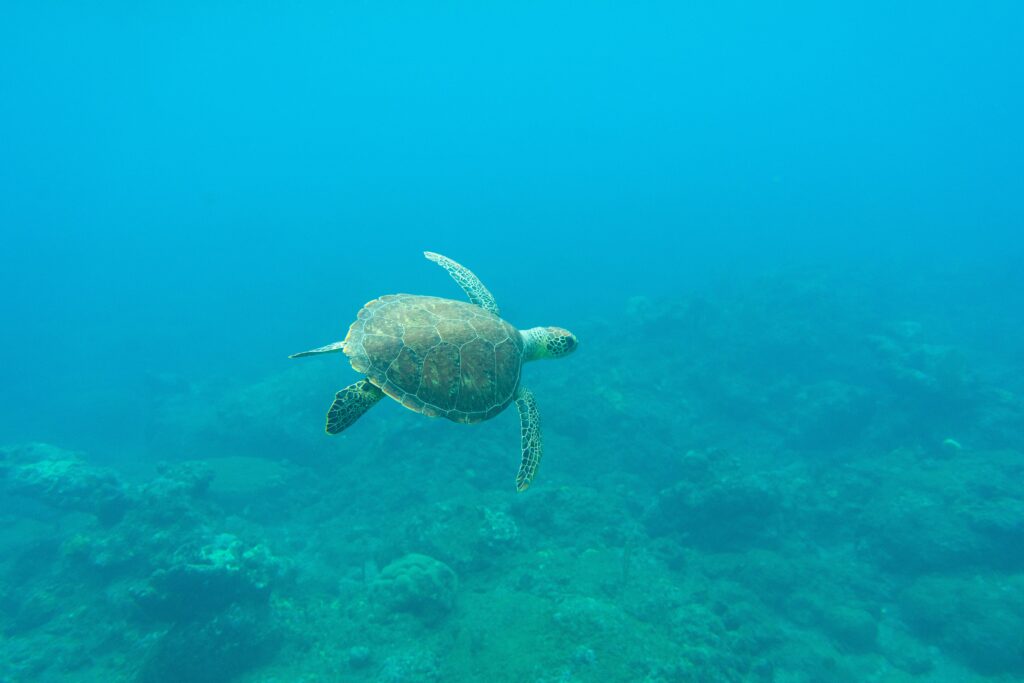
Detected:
left=289, top=252, right=579, bottom=490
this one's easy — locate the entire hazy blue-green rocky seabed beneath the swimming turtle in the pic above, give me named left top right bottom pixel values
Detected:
left=0, top=275, right=1024, bottom=683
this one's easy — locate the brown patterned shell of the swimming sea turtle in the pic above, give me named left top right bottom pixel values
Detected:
left=345, top=294, right=523, bottom=422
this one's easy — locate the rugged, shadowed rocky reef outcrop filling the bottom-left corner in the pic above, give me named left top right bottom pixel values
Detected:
left=0, top=443, right=291, bottom=682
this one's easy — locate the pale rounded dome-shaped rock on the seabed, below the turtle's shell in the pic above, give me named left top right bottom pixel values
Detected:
left=372, top=553, right=459, bottom=622
